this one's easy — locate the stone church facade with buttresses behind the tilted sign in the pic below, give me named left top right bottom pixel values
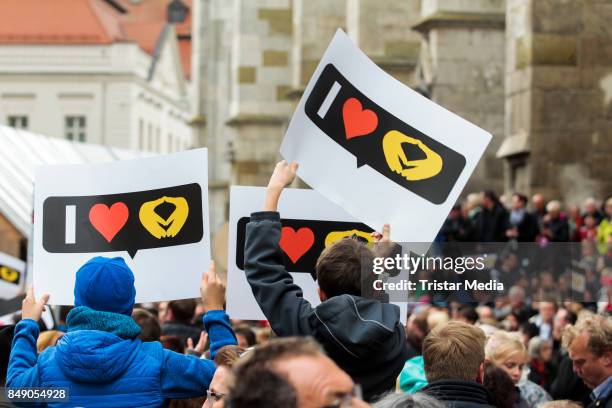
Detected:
left=192, top=0, right=612, bottom=233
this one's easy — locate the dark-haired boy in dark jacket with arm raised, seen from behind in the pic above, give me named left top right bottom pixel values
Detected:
left=244, top=161, right=407, bottom=400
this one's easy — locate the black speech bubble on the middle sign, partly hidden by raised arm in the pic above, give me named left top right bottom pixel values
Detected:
left=236, top=217, right=374, bottom=279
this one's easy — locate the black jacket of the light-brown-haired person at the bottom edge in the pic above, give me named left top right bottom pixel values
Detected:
left=421, top=380, right=494, bottom=408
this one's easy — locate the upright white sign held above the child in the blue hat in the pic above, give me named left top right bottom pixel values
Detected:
left=33, top=149, right=210, bottom=304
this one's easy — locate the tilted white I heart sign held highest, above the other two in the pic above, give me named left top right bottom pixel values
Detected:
left=280, top=30, right=491, bottom=250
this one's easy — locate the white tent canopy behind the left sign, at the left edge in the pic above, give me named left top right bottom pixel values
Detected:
left=0, top=125, right=151, bottom=238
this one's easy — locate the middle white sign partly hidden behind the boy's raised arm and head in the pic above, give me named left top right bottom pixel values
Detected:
left=227, top=186, right=406, bottom=322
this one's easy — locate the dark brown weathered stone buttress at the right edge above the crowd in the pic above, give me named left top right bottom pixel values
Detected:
left=498, top=0, right=612, bottom=204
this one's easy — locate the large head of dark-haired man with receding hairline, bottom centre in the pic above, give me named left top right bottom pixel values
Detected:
left=225, top=337, right=368, bottom=408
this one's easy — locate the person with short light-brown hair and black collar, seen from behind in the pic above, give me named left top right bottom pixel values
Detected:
left=422, top=321, right=493, bottom=408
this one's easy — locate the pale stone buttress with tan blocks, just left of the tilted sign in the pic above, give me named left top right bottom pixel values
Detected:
left=226, top=0, right=293, bottom=185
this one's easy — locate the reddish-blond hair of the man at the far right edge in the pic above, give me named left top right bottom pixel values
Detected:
left=562, top=313, right=612, bottom=357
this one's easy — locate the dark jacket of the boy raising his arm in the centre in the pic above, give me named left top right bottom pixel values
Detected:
left=244, top=212, right=408, bottom=400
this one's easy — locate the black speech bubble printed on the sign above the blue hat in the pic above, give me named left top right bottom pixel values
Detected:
left=43, top=183, right=204, bottom=258
